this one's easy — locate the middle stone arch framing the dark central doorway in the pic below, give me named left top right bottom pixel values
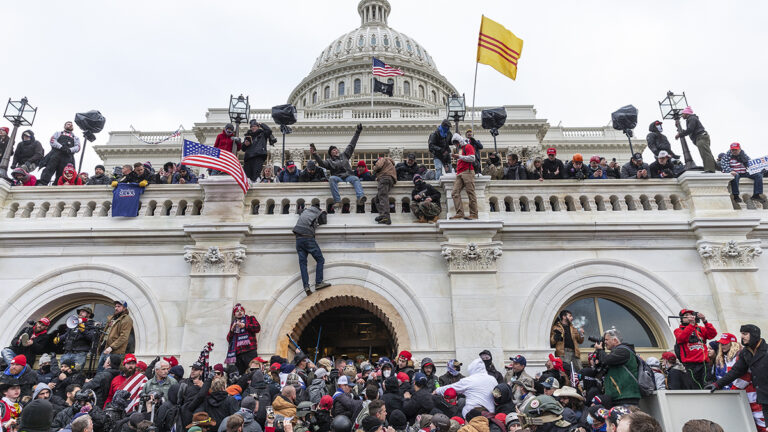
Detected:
left=258, top=262, right=428, bottom=354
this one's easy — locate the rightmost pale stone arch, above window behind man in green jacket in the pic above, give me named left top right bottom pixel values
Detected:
left=520, top=259, right=683, bottom=348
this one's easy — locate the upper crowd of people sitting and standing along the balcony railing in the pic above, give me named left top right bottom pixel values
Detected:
left=0, top=107, right=768, bottom=211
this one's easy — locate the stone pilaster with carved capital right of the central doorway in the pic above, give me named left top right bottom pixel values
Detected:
left=438, top=220, right=504, bottom=364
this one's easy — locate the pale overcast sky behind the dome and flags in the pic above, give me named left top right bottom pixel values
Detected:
left=0, top=0, right=768, bottom=172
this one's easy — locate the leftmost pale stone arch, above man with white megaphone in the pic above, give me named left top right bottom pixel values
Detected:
left=0, top=264, right=166, bottom=355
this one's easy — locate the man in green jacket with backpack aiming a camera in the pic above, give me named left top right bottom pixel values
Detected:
left=595, top=329, right=642, bottom=406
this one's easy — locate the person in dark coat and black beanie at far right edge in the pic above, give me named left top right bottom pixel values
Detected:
left=706, top=324, right=768, bottom=413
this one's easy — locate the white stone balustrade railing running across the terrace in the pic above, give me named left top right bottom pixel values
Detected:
left=0, top=173, right=764, bottom=224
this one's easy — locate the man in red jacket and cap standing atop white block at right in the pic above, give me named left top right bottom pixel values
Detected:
left=675, top=309, right=717, bottom=390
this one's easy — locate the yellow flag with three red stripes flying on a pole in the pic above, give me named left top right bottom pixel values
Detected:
left=477, top=15, right=523, bottom=79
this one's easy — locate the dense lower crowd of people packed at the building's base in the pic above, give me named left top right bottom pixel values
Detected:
left=0, top=300, right=768, bottom=432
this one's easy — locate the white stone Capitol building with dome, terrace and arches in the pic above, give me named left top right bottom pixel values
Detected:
left=0, top=0, right=768, bottom=378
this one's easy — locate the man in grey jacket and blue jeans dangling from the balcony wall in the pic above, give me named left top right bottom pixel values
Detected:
left=293, top=206, right=331, bottom=295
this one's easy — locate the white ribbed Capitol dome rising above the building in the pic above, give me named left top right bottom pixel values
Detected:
left=288, top=0, right=458, bottom=109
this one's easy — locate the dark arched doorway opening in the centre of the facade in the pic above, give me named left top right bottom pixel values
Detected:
left=297, top=306, right=397, bottom=361
